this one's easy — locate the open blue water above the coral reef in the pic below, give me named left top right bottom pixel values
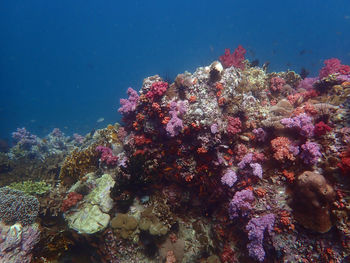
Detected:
left=0, top=0, right=350, bottom=143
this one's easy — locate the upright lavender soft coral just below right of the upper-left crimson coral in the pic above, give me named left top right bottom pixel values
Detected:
left=165, top=101, right=187, bottom=137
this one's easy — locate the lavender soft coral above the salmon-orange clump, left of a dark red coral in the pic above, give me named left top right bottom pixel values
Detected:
left=281, top=113, right=314, bottom=138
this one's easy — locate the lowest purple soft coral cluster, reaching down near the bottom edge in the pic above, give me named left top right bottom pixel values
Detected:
left=246, top=214, right=275, bottom=262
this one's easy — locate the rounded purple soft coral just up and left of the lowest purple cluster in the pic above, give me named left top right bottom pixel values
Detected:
left=228, top=189, right=254, bottom=219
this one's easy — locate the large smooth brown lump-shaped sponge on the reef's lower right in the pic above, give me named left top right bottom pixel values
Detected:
left=293, top=171, right=335, bottom=233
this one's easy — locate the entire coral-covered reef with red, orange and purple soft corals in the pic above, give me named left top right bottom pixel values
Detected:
left=0, top=46, right=350, bottom=263
